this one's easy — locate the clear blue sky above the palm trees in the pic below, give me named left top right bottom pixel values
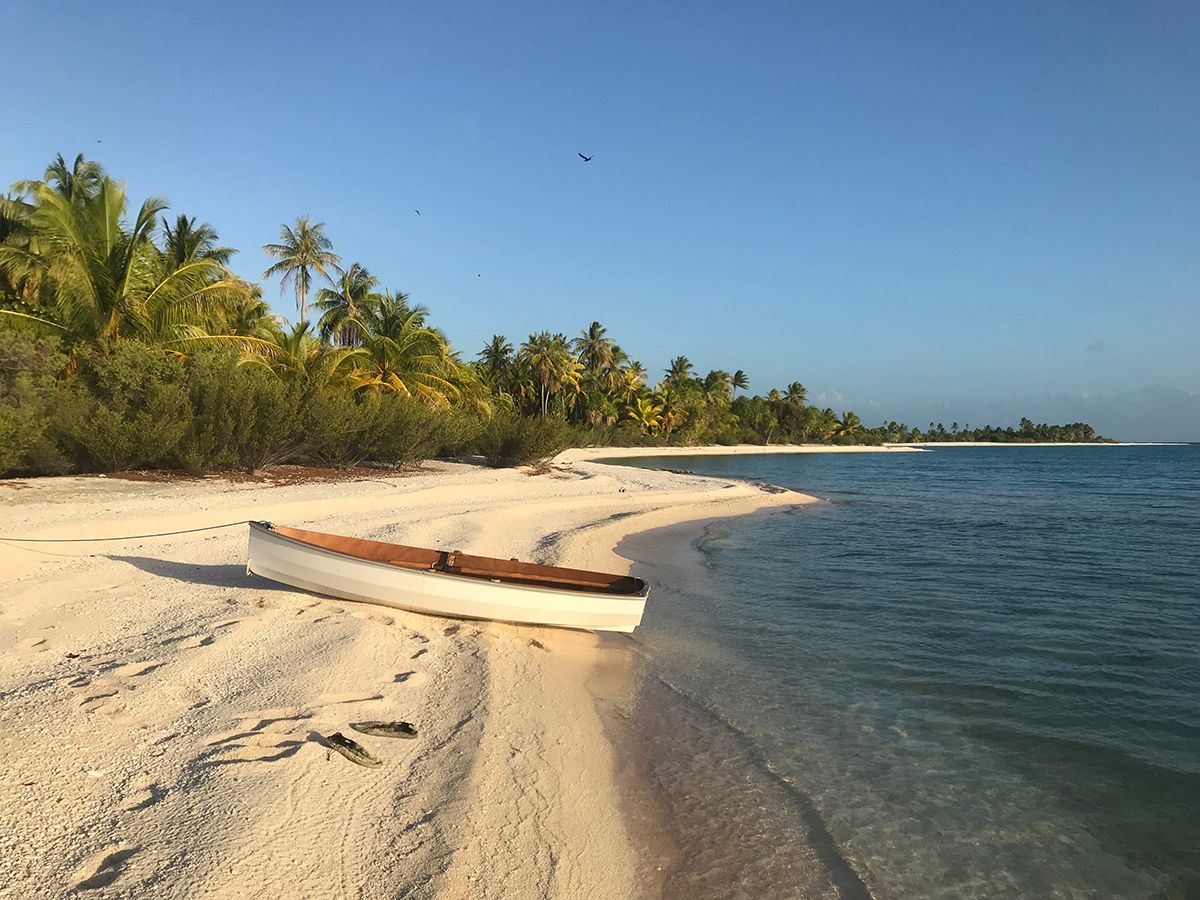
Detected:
left=0, top=0, right=1200, bottom=440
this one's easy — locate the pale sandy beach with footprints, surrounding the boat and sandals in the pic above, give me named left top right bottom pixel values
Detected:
left=0, top=448, right=812, bottom=899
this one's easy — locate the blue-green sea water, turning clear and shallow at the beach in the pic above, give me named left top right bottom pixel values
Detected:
left=622, top=445, right=1200, bottom=898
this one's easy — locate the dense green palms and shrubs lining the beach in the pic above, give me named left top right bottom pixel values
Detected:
left=0, top=156, right=1096, bottom=474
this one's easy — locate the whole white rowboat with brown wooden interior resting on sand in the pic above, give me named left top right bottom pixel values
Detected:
left=246, top=522, right=649, bottom=631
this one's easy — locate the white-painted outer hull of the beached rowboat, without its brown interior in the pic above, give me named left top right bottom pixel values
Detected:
left=246, top=523, right=646, bottom=632
